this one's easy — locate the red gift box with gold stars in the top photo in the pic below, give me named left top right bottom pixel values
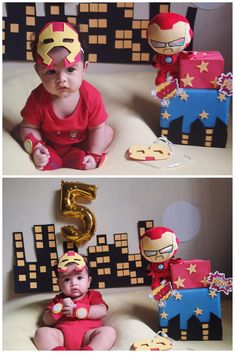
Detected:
left=179, top=51, right=224, bottom=89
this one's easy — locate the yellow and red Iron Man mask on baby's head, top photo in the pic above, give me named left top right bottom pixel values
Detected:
left=37, top=22, right=81, bottom=67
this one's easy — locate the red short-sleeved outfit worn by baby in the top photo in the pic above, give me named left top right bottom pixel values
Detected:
left=21, top=80, right=108, bottom=169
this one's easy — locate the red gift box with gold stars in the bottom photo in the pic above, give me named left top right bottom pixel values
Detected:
left=170, top=260, right=211, bottom=290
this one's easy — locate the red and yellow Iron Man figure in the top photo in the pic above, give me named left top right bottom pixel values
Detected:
left=147, top=12, right=193, bottom=86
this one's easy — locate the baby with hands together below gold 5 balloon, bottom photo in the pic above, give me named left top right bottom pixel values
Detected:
left=34, top=251, right=116, bottom=351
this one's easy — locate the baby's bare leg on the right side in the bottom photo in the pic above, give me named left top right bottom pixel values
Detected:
left=81, top=326, right=116, bottom=351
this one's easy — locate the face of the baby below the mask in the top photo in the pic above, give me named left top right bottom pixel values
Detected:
left=35, top=48, right=87, bottom=98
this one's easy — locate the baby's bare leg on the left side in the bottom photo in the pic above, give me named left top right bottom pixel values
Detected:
left=34, top=327, right=64, bottom=351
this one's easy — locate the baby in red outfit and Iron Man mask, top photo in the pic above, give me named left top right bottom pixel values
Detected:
left=19, top=22, right=113, bottom=170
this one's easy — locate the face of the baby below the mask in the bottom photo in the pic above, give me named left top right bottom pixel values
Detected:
left=58, top=266, right=91, bottom=299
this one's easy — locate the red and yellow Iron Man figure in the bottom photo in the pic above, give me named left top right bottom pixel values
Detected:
left=140, top=227, right=181, bottom=291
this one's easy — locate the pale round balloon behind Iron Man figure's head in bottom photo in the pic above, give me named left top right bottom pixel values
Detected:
left=162, top=201, right=201, bottom=242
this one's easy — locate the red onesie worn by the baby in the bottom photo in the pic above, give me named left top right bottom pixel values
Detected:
left=47, top=290, right=108, bottom=350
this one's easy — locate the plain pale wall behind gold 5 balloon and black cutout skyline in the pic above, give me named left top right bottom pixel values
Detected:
left=3, top=178, right=232, bottom=301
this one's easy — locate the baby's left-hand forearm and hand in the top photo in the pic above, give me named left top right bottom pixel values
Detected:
left=20, top=122, right=50, bottom=169
